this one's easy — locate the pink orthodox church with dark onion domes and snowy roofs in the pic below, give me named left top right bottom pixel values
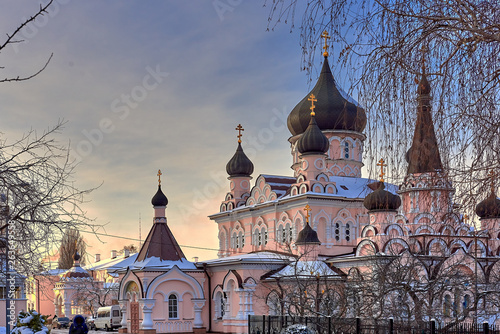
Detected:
left=108, top=34, right=500, bottom=333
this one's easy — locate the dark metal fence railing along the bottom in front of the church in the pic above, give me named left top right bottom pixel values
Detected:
left=248, top=315, right=500, bottom=334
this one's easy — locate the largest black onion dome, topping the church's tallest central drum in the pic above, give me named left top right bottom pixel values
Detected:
left=287, top=57, right=366, bottom=136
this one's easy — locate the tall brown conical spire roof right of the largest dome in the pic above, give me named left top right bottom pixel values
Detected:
left=406, top=71, right=443, bottom=174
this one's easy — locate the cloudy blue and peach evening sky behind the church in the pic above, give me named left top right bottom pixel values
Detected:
left=0, top=0, right=340, bottom=260
